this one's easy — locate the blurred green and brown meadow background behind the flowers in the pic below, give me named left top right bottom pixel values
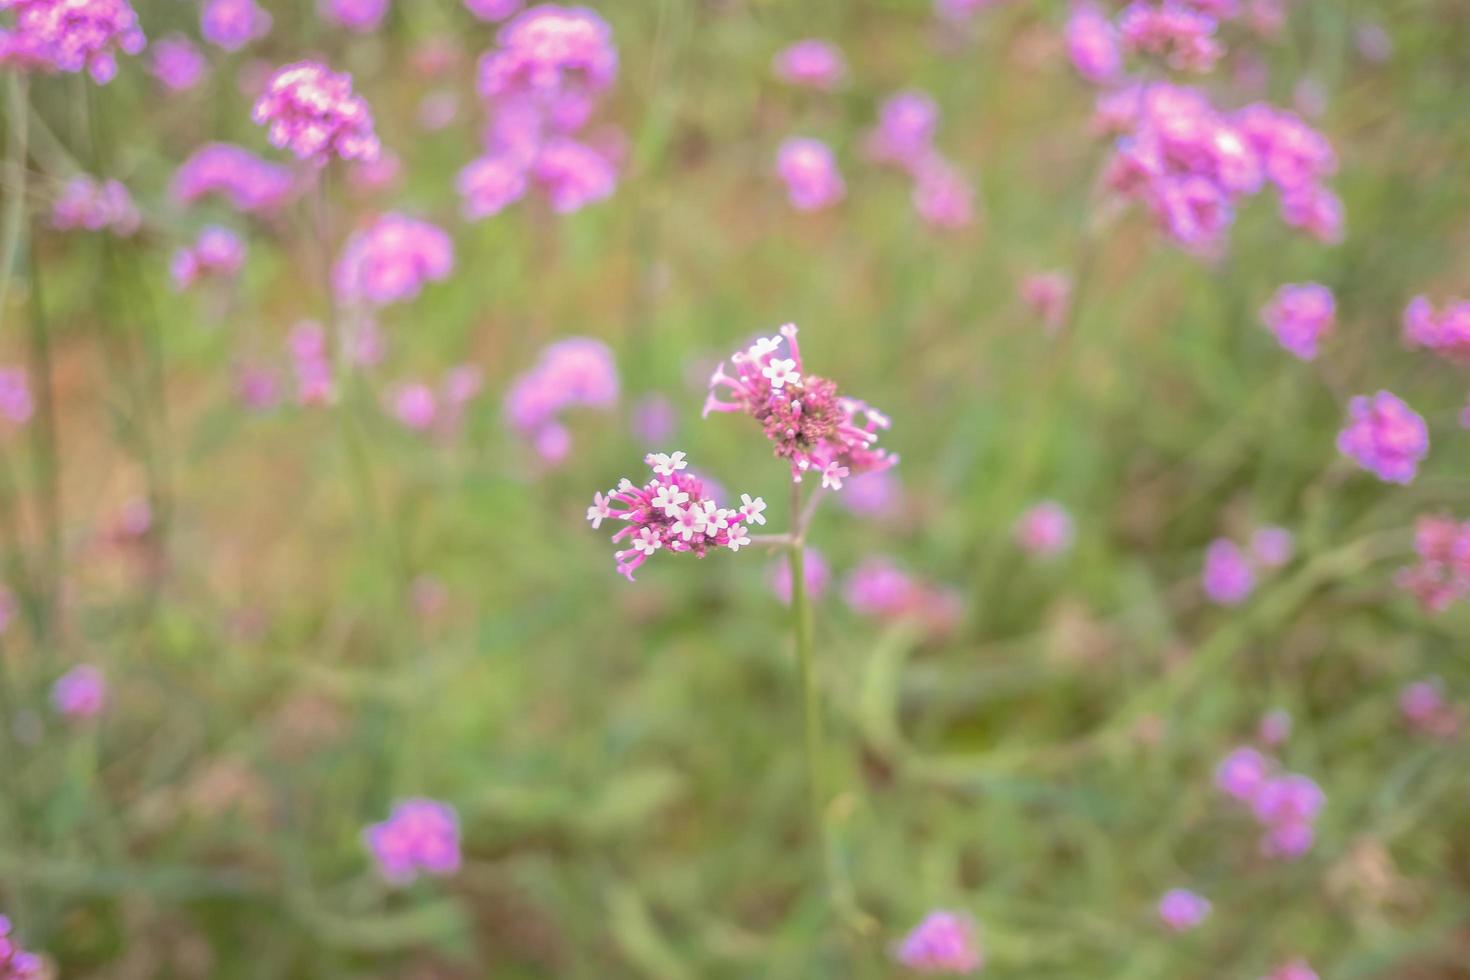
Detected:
left=0, top=0, right=1470, bottom=980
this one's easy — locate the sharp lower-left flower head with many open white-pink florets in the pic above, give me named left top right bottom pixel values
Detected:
left=587, top=453, right=766, bottom=582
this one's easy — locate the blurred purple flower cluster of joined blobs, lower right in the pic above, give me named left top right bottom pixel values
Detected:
left=1214, top=746, right=1327, bottom=858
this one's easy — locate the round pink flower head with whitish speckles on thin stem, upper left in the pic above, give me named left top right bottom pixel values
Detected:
left=251, top=62, right=381, bottom=166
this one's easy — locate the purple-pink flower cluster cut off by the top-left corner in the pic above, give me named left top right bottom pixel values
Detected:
left=0, top=0, right=147, bottom=85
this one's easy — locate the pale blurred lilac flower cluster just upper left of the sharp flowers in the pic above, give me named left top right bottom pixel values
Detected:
left=506, top=336, right=617, bottom=463
